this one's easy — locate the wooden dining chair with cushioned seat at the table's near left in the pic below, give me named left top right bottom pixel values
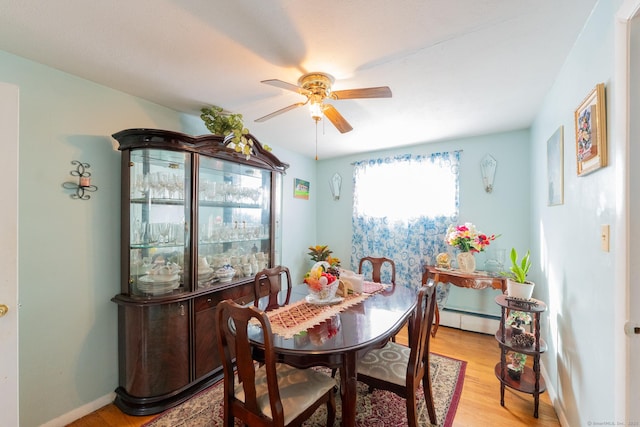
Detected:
left=216, top=299, right=336, bottom=427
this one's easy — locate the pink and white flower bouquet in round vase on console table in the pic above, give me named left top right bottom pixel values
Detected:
left=445, top=222, right=499, bottom=273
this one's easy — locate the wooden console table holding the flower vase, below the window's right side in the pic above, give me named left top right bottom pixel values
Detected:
left=422, top=265, right=507, bottom=337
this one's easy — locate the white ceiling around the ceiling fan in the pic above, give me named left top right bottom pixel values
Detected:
left=0, top=0, right=597, bottom=159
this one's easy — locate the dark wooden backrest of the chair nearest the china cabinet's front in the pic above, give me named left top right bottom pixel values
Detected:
left=216, top=299, right=284, bottom=425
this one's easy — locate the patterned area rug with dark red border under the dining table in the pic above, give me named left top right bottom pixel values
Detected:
left=144, top=353, right=467, bottom=427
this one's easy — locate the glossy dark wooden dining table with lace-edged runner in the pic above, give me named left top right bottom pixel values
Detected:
left=248, top=281, right=417, bottom=426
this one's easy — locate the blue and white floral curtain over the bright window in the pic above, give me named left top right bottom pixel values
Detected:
left=351, top=151, right=460, bottom=288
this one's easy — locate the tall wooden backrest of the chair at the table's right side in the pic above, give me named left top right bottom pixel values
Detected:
left=407, top=283, right=436, bottom=386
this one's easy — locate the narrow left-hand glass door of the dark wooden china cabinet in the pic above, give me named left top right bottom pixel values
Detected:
left=129, top=149, right=192, bottom=297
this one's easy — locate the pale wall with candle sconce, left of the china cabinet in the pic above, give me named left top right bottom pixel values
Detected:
left=0, top=52, right=185, bottom=427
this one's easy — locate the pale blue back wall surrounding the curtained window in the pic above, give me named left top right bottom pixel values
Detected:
left=313, top=131, right=530, bottom=316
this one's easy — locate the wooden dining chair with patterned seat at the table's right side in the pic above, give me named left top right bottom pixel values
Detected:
left=358, top=285, right=437, bottom=427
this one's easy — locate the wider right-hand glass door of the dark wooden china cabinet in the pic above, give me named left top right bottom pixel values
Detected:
left=197, top=156, right=271, bottom=288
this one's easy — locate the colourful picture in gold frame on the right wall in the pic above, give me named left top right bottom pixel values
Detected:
left=575, top=83, right=607, bottom=176
